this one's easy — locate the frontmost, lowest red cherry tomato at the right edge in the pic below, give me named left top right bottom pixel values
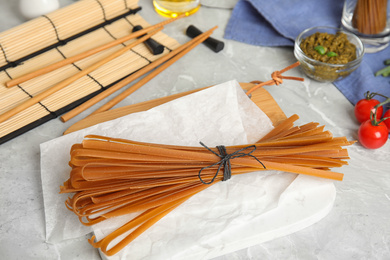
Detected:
left=358, top=120, right=389, bottom=149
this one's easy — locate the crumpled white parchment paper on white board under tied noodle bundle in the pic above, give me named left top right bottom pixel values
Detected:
left=41, top=81, right=335, bottom=259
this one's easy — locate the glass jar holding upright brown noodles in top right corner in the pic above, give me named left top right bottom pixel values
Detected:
left=341, top=0, right=390, bottom=53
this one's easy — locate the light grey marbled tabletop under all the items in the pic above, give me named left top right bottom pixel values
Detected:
left=0, top=0, right=390, bottom=260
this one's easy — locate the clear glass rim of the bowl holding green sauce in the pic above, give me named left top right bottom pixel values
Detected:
left=294, top=26, right=366, bottom=68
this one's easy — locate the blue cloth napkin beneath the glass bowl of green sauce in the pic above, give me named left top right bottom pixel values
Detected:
left=224, top=0, right=390, bottom=107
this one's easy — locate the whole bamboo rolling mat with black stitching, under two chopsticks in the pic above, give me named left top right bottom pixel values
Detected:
left=0, top=0, right=179, bottom=144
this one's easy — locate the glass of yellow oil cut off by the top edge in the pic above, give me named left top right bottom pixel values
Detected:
left=153, top=0, right=200, bottom=18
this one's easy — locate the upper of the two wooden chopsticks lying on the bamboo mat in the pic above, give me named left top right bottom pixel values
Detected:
left=5, top=15, right=185, bottom=88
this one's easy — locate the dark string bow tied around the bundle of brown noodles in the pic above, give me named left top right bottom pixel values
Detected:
left=198, top=142, right=266, bottom=184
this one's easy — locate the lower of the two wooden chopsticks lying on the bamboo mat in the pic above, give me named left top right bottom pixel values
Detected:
left=0, top=27, right=162, bottom=123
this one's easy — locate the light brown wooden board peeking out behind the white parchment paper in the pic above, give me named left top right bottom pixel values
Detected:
left=64, top=83, right=287, bottom=134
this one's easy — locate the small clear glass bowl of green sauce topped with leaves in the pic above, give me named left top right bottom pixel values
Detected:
left=294, top=26, right=364, bottom=82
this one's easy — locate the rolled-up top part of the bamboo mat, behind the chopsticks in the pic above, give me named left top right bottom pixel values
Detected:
left=0, top=0, right=138, bottom=69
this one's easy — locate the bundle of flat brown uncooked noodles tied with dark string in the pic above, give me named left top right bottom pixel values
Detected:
left=61, top=115, right=353, bottom=255
